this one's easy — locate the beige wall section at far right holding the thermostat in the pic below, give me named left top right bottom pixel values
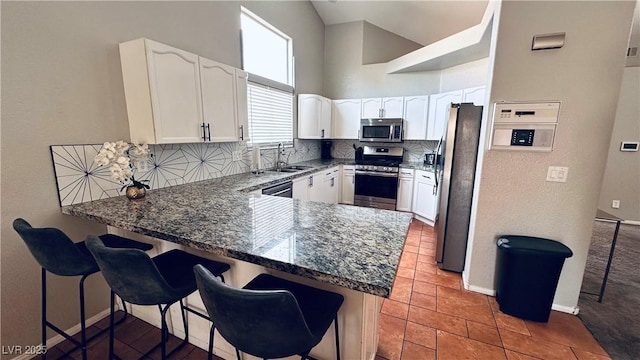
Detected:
left=598, top=67, right=640, bottom=222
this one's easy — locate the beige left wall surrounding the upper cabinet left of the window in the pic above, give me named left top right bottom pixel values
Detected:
left=0, top=2, right=324, bottom=346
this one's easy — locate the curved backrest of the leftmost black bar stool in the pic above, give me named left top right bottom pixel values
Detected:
left=13, top=218, right=98, bottom=276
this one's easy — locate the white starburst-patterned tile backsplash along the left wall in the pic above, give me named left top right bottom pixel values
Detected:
left=50, top=140, right=320, bottom=206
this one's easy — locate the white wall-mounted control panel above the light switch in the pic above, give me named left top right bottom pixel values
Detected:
left=490, top=101, right=560, bottom=151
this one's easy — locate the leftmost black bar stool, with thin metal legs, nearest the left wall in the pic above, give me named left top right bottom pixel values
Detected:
left=13, top=218, right=153, bottom=360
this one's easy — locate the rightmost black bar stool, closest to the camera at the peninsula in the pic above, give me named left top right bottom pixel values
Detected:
left=194, top=266, right=344, bottom=360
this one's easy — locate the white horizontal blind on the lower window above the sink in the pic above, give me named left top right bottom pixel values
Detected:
left=247, top=82, right=293, bottom=147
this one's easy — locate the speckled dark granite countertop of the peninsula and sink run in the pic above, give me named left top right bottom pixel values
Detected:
left=62, top=159, right=412, bottom=297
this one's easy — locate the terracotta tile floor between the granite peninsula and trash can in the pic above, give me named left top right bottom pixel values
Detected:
left=376, top=220, right=610, bottom=360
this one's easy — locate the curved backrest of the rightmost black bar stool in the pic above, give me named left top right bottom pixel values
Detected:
left=194, top=265, right=318, bottom=358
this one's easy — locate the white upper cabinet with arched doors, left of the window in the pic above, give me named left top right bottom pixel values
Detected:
left=120, top=39, right=247, bottom=144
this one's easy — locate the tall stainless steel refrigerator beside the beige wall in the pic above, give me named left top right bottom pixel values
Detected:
left=436, top=103, right=482, bottom=272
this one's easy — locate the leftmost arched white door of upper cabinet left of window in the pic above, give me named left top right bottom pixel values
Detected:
left=146, top=40, right=203, bottom=144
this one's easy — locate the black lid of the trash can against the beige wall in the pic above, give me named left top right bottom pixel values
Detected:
left=497, top=235, right=573, bottom=258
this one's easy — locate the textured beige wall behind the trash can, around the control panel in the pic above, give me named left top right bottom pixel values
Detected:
left=464, top=1, right=635, bottom=309
